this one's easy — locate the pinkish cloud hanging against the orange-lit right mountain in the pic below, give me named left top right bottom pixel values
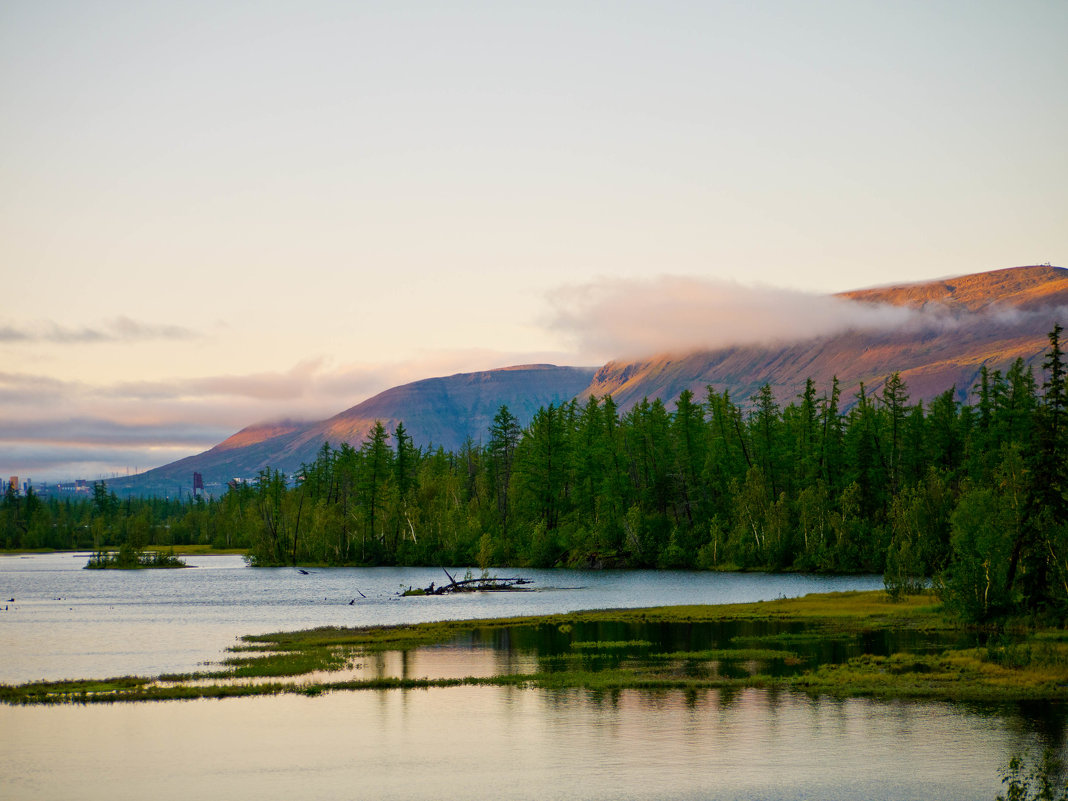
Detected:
left=549, top=276, right=956, bottom=360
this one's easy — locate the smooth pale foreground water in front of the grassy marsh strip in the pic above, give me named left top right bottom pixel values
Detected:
left=0, top=687, right=1064, bottom=801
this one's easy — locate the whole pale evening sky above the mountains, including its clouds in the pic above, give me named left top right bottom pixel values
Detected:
left=0, top=0, right=1068, bottom=484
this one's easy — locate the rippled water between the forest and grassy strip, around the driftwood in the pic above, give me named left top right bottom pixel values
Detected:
left=0, top=553, right=882, bottom=682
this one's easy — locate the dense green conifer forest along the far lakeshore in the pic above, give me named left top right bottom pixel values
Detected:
left=0, top=326, right=1068, bottom=621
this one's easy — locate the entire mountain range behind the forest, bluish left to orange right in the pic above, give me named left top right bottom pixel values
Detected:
left=109, top=265, right=1068, bottom=494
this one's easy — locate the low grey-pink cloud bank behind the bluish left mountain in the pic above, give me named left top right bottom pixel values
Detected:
left=0, top=349, right=562, bottom=483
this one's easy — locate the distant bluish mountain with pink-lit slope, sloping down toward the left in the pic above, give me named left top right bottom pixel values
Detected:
left=108, top=364, right=594, bottom=494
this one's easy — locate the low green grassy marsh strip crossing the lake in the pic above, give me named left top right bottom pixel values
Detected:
left=0, top=592, right=1068, bottom=704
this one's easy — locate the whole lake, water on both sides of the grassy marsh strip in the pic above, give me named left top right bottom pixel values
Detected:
left=0, top=554, right=1066, bottom=800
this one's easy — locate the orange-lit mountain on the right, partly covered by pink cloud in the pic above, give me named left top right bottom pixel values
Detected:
left=582, top=265, right=1068, bottom=409
